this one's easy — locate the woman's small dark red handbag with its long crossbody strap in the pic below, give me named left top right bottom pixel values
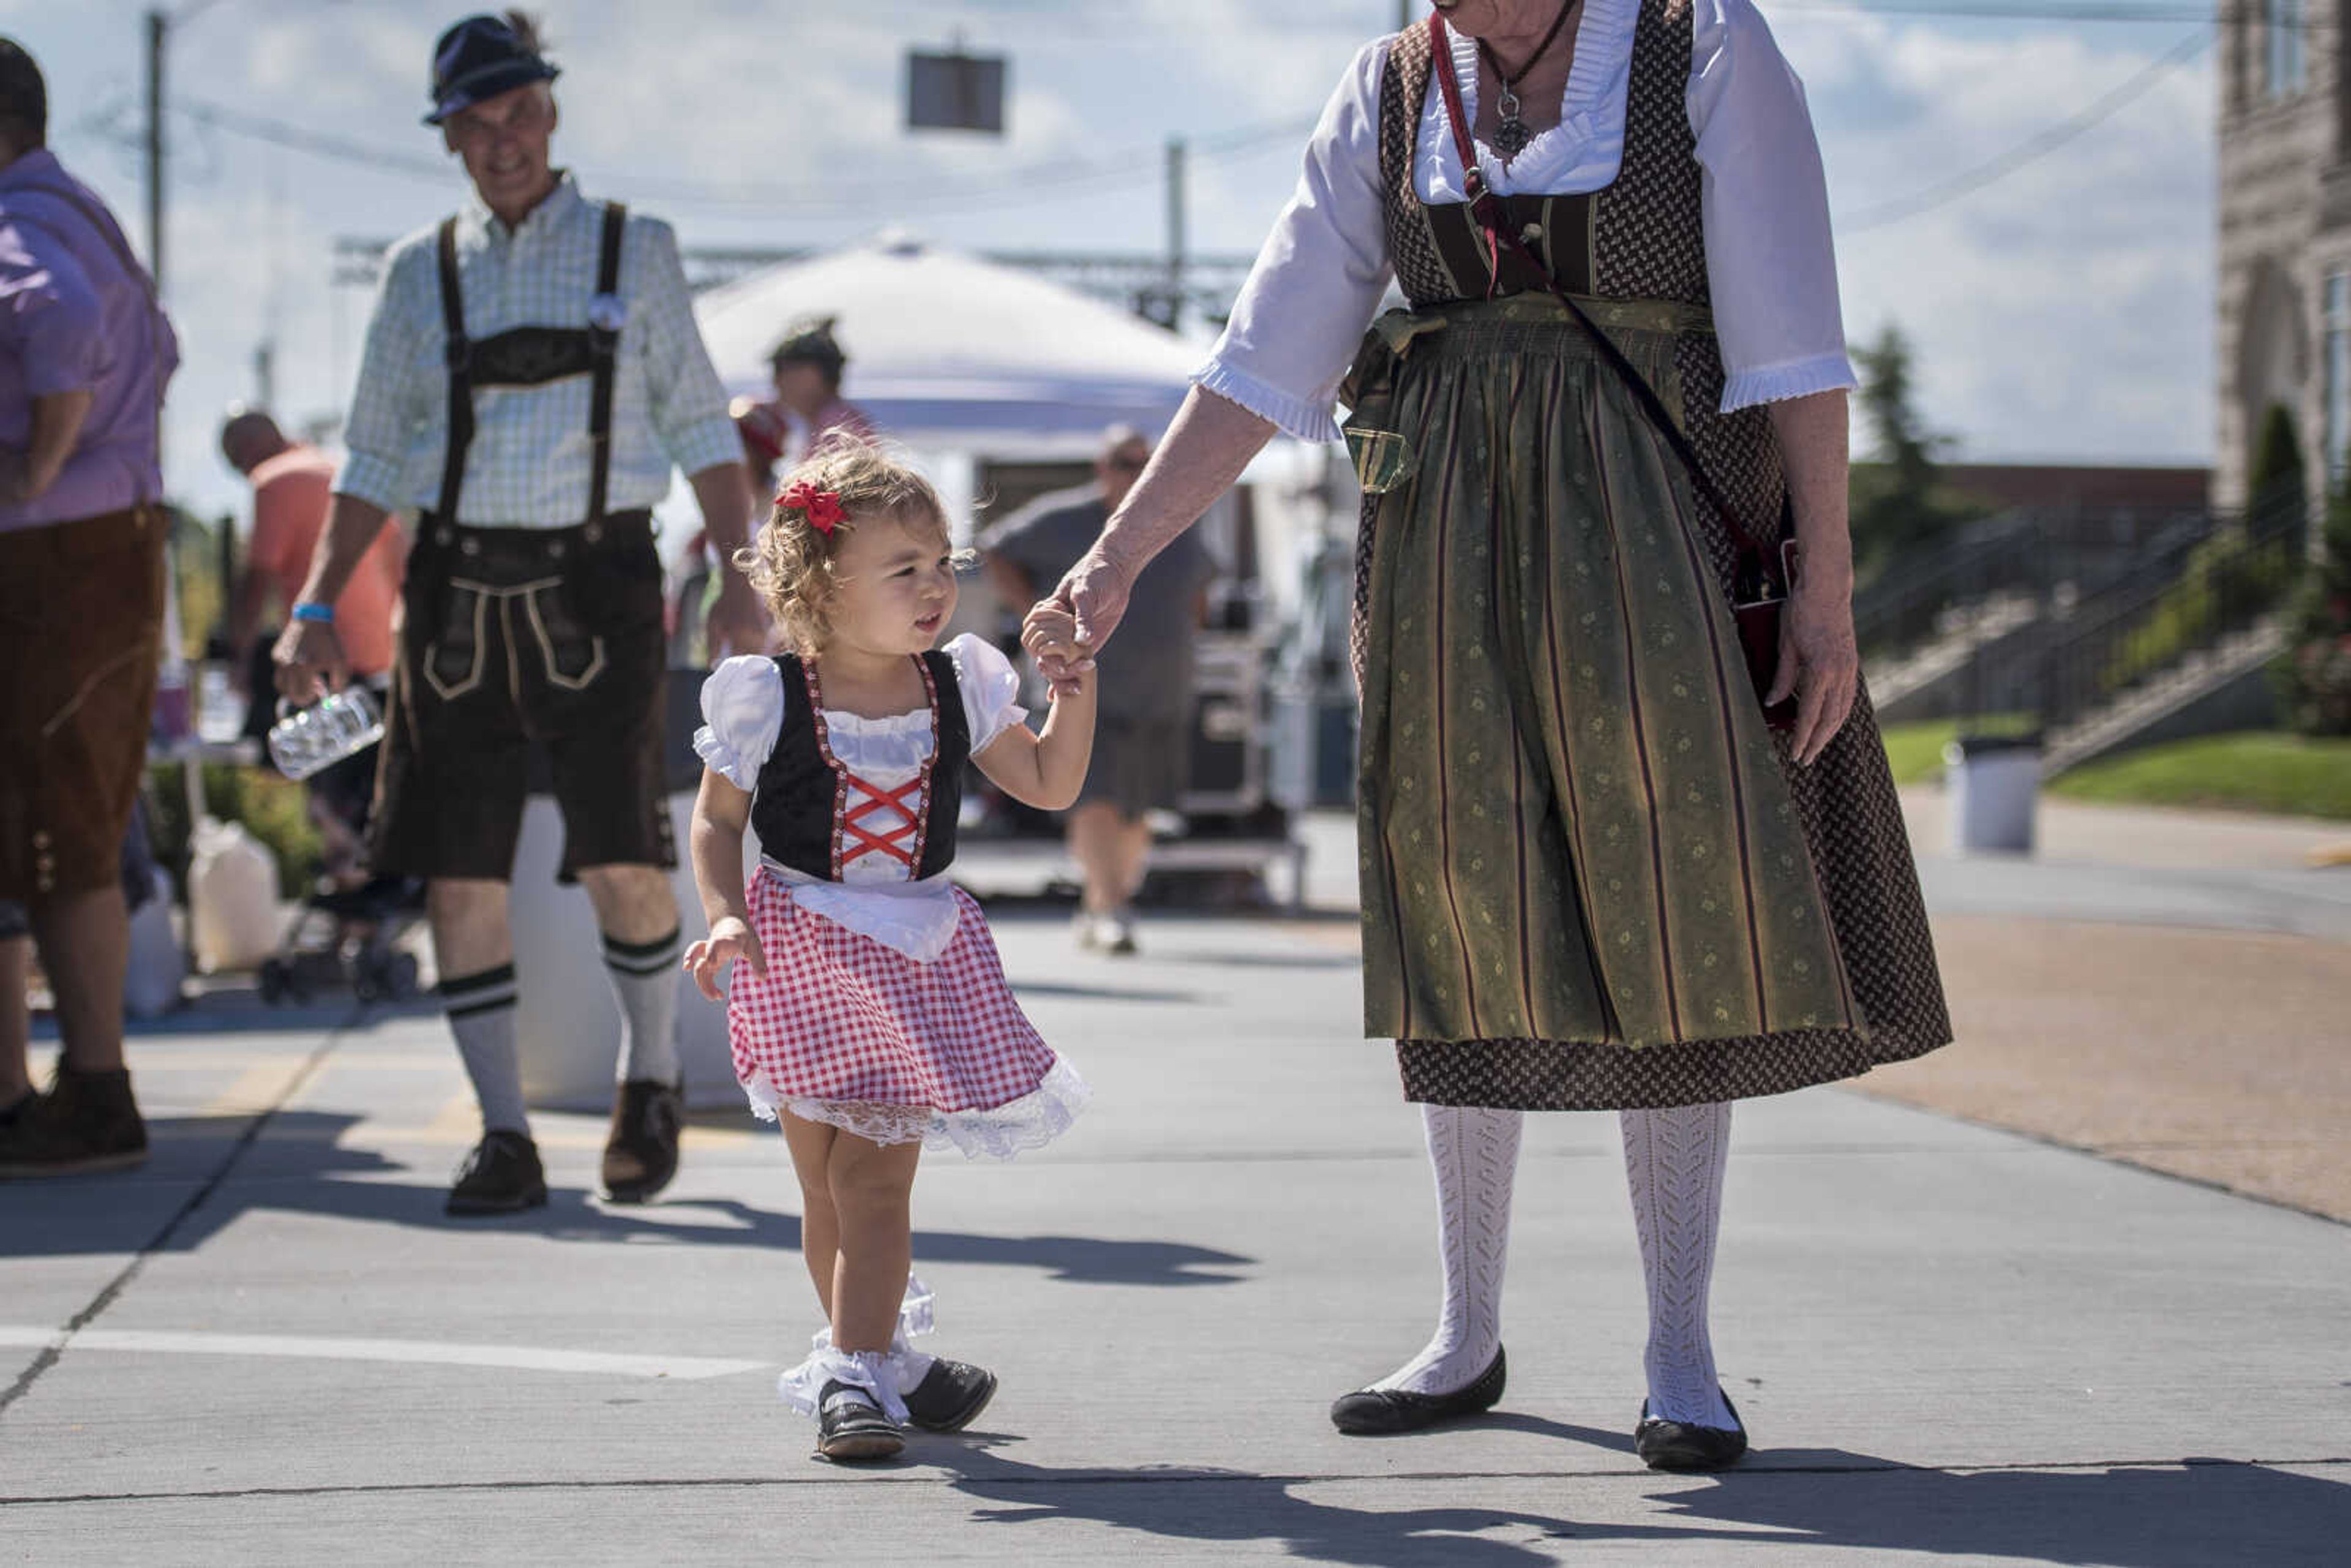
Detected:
left=1430, top=12, right=1796, bottom=731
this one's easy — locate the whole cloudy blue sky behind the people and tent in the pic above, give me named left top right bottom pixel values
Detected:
left=0, top=0, right=2214, bottom=522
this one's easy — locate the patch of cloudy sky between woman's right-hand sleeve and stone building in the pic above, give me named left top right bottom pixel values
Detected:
left=1780, top=19, right=2214, bottom=463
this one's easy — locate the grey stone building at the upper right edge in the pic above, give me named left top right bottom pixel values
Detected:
left=2219, top=0, right=2351, bottom=508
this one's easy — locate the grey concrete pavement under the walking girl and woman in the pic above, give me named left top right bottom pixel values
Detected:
left=0, top=915, right=2351, bottom=1568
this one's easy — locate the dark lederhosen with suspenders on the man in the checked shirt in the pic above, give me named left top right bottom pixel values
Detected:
left=374, top=202, right=677, bottom=879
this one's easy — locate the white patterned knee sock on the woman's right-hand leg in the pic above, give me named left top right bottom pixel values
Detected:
left=1618, top=1103, right=1735, bottom=1429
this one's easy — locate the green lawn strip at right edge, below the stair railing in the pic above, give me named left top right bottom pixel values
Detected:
left=2048, top=731, right=2351, bottom=820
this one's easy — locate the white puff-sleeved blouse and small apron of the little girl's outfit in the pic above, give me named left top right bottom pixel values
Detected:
left=694, top=635, right=1027, bottom=964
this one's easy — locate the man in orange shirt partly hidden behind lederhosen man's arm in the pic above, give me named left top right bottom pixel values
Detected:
left=221, top=411, right=409, bottom=696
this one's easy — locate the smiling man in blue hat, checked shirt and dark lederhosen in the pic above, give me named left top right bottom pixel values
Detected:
left=277, top=12, right=762, bottom=1215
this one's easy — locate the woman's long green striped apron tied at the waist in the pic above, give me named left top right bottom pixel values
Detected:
left=1343, top=294, right=1864, bottom=1048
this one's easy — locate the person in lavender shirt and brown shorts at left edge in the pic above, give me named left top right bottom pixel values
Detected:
left=0, top=37, right=179, bottom=1178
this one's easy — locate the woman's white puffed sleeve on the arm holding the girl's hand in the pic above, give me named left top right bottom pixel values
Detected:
left=1192, top=40, right=1389, bottom=442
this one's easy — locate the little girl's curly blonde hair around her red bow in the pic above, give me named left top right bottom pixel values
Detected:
left=733, top=442, right=952, bottom=658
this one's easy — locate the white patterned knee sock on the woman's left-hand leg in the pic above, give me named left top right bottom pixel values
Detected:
left=1371, top=1105, right=1523, bottom=1394
